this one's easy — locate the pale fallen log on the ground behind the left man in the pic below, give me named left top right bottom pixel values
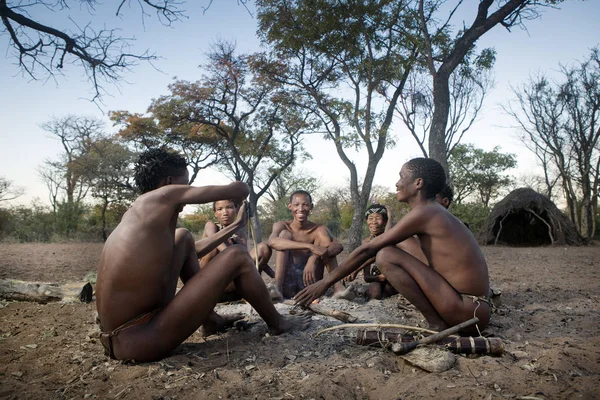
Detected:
left=0, top=279, right=93, bottom=304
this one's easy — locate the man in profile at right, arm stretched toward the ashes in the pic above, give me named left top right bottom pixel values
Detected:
left=294, top=158, right=491, bottom=333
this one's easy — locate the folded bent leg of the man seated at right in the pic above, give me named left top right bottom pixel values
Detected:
left=376, top=246, right=489, bottom=329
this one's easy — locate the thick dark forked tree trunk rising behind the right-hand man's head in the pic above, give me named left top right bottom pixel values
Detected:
left=418, top=0, right=558, bottom=170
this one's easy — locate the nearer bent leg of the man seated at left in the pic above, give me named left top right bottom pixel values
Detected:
left=113, top=245, right=310, bottom=361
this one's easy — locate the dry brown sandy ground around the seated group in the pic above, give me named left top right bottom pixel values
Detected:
left=0, top=244, right=600, bottom=399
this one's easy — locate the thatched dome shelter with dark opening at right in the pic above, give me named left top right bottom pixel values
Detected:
left=479, top=188, right=585, bottom=246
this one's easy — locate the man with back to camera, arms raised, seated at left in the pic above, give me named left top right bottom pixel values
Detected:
left=96, top=150, right=310, bottom=361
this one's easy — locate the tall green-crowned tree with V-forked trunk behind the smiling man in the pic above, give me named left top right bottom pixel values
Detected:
left=257, top=0, right=420, bottom=250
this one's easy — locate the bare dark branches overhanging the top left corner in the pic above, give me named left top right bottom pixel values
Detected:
left=0, top=0, right=183, bottom=100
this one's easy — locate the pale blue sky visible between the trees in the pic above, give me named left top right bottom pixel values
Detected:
left=0, top=0, right=600, bottom=204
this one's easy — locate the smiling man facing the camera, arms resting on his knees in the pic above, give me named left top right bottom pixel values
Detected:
left=269, top=190, right=353, bottom=300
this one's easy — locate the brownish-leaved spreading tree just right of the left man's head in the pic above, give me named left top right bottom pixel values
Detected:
left=151, top=42, right=312, bottom=241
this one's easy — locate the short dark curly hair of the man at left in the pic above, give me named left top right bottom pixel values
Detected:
left=134, top=149, right=187, bottom=194
